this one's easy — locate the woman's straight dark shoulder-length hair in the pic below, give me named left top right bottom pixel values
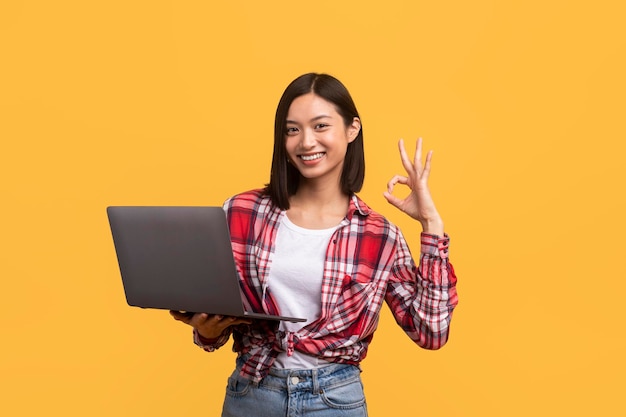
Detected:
left=265, top=73, right=365, bottom=210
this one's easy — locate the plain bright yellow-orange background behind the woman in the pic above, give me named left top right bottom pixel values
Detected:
left=0, top=0, right=626, bottom=416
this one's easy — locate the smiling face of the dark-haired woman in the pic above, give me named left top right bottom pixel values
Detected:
left=285, top=93, right=361, bottom=184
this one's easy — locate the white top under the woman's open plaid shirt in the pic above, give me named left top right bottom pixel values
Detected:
left=269, top=215, right=339, bottom=369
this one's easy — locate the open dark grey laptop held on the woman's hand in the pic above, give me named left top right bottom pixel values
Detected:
left=107, top=206, right=306, bottom=322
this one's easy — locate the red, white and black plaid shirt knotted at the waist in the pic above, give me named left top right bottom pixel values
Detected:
left=194, top=190, right=458, bottom=381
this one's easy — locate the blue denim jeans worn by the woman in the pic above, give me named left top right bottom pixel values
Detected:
left=222, top=360, right=367, bottom=417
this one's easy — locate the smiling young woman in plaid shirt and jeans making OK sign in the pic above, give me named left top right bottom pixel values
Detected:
left=171, top=73, right=457, bottom=417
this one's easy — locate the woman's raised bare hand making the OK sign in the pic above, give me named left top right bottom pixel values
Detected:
left=384, top=138, right=444, bottom=236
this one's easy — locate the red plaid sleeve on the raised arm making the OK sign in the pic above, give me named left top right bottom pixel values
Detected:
left=385, top=230, right=458, bottom=349
